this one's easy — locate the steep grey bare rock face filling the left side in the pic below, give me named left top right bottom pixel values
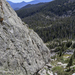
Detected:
left=0, top=0, right=50, bottom=75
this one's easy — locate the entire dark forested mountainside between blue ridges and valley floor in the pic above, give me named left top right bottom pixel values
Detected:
left=16, top=0, right=75, bottom=42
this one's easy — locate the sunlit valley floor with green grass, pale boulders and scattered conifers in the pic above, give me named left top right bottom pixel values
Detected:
left=40, top=39, right=75, bottom=75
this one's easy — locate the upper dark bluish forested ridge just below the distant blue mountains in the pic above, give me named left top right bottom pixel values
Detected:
left=17, top=0, right=74, bottom=18
